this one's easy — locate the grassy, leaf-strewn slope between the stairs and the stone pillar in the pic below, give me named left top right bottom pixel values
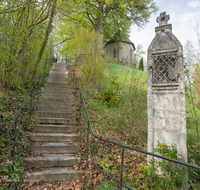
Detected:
left=76, top=64, right=147, bottom=189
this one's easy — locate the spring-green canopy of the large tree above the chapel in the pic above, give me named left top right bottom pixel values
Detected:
left=55, top=0, right=158, bottom=59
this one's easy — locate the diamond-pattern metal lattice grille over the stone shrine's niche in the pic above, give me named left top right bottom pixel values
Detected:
left=152, top=52, right=178, bottom=83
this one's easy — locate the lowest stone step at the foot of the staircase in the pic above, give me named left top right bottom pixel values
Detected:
left=25, top=168, right=83, bottom=182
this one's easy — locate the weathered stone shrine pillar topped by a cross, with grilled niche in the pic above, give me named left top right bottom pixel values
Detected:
left=147, top=12, right=187, bottom=162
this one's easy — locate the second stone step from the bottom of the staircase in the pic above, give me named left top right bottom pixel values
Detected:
left=25, top=154, right=80, bottom=167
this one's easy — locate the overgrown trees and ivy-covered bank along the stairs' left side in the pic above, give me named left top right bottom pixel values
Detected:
left=0, top=0, right=56, bottom=189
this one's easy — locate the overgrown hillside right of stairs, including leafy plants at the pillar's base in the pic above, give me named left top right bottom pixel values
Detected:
left=73, top=59, right=200, bottom=189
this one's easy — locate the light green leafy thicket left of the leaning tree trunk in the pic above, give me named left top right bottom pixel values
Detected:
left=0, top=0, right=52, bottom=92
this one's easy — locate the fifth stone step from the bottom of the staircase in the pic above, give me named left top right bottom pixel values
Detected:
left=32, top=125, right=79, bottom=133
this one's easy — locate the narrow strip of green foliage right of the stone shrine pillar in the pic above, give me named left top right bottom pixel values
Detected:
left=184, top=62, right=200, bottom=184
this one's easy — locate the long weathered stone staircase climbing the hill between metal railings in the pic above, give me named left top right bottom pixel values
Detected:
left=25, top=63, right=83, bottom=182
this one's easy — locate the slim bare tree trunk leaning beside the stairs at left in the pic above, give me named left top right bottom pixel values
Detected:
left=31, top=0, right=56, bottom=81
